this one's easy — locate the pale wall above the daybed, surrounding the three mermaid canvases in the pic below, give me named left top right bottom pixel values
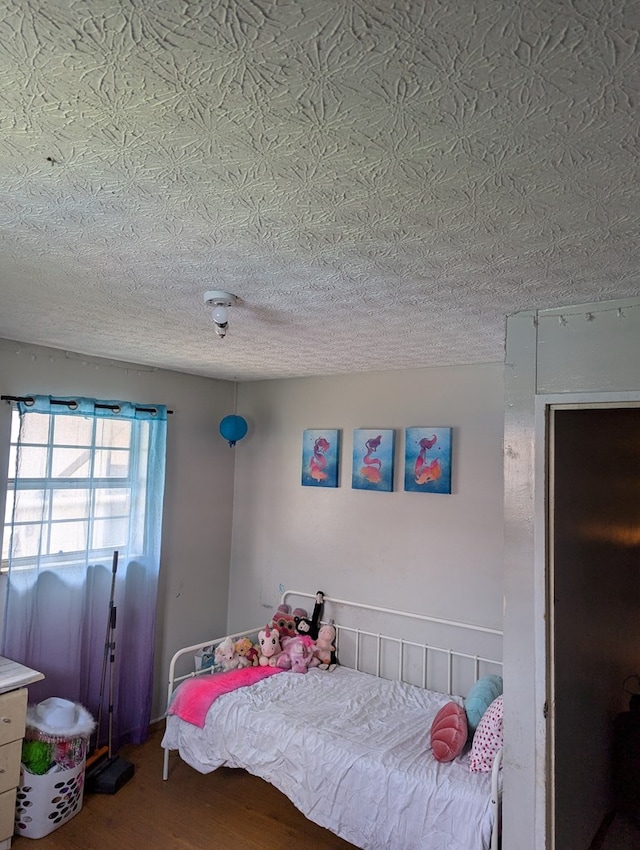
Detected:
left=229, top=363, right=503, bottom=629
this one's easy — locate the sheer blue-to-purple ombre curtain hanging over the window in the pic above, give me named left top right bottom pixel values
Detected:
left=2, top=396, right=167, bottom=747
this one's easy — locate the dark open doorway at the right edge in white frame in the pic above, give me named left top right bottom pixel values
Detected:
left=549, top=406, right=640, bottom=850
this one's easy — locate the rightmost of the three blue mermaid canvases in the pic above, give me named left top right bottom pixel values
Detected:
left=404, top=428, right=451, bottom=493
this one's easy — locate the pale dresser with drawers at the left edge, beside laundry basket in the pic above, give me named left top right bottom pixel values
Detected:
left=0, top=655, right=44, bottom=850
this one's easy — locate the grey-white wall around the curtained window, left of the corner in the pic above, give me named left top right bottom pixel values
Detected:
left=0, top=340, right=234, bottom=717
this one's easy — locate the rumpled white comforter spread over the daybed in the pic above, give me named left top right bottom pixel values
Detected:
left=162, top=667, right=491, bottom=850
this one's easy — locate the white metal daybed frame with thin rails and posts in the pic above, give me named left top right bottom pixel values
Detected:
left=162, top=590, right=502, bottom=850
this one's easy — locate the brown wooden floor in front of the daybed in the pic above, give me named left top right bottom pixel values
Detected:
left=12, top=727, right=353, bottom=850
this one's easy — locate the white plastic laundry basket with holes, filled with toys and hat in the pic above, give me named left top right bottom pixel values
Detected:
left=15, top=697, right=95, bottom=838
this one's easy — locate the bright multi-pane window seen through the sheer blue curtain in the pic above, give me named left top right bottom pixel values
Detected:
left=2, top=410, right=149, bottom=569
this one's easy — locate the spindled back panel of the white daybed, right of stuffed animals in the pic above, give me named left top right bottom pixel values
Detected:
left=281, top=590, right=502, bottom=696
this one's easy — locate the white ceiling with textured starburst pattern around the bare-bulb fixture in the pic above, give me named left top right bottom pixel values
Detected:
left=0, top=0, right=640, bottom=380
